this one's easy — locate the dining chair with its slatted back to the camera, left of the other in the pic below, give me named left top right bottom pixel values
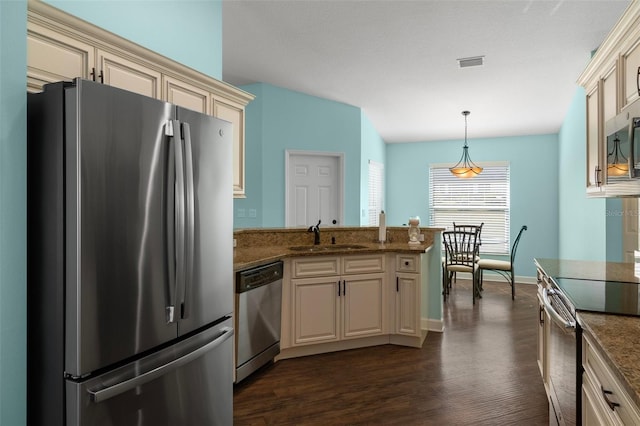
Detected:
left=442, top=231, right=480, bottom=304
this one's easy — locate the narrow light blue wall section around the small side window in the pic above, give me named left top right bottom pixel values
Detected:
left=360, top=112, right=386, bottom=226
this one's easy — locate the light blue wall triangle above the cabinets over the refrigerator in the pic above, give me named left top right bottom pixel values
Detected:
left=45, top=0, right=222, bottom=80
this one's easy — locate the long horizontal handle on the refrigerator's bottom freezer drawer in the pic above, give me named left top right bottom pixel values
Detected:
left=87, top=327, right=233, bottom=403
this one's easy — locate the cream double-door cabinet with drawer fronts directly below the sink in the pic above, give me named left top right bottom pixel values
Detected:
left=291, top=255, right=386, bottom=346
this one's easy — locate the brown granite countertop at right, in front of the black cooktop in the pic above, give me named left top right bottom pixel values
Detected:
left=576, top=311, right=640, bottom=407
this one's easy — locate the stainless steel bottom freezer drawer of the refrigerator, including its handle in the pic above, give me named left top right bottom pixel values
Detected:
left=66, top=319, right=233, bottom=426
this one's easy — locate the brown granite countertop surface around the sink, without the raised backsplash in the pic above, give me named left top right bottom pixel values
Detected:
left=233, top=242, right=431, bottom=271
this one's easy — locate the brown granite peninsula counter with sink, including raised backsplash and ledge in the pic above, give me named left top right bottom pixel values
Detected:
left=233, top=227, right=443, bottom=271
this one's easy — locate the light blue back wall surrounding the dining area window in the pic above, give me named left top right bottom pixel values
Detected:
left=386, top=135, right=558, bottom=277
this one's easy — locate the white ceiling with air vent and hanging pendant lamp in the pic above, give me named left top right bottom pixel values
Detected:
left=223, top=0, right=629, bottom=142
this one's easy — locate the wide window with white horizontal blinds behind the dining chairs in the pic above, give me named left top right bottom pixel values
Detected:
left=429, top=162, right=510, bottom=254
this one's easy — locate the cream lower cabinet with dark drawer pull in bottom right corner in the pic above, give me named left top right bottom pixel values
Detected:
left=582, top=335, right=640, bottom=426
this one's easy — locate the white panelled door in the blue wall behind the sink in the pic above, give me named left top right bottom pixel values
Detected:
left=285, top=151, right=343, bottom=226
